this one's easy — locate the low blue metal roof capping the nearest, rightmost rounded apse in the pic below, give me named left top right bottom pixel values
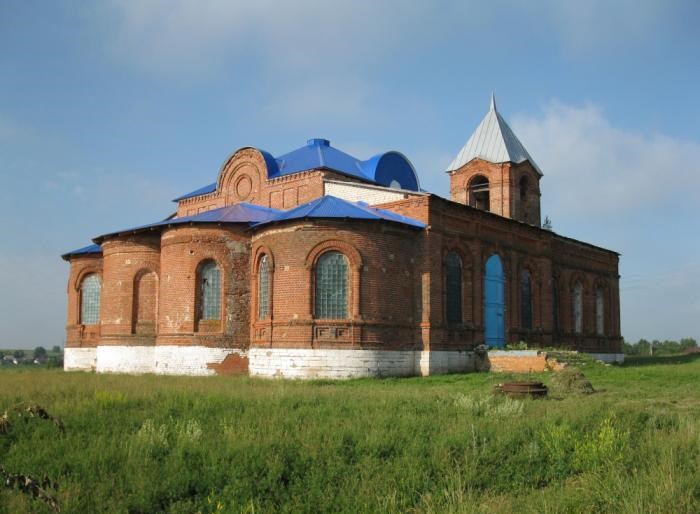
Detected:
left=255, top=195, right=426, bottom=228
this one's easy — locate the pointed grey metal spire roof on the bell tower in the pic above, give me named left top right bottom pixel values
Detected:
left=447, top=93, right=542, bottom=175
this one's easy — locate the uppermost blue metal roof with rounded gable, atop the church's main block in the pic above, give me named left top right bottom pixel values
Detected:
left=173, top=138, right=420, bottom=202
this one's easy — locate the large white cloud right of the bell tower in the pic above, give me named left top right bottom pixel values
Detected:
left=512, top=101, right=700, bottom=217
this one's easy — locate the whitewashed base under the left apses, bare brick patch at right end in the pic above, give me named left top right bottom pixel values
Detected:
left=63, top=346, right=247, bottom=375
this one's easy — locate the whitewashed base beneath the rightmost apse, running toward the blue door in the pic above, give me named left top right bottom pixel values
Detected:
left=248, top=348, right=474, bottom=379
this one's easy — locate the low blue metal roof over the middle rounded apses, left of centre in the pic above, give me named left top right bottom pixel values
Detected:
left=93, top=202, right=283, bottom=241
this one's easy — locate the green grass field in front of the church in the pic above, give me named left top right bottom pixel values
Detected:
left=0, top=357, right=700, bottom=514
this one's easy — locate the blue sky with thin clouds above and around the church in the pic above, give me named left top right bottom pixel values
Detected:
left=0, top=0, right=700, bottom=348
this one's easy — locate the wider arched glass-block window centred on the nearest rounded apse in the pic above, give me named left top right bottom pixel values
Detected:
left=314, top=251, right=348, bottom=319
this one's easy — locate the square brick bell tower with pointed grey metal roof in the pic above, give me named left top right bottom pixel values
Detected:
left=447, top=94, right=542, bottom=227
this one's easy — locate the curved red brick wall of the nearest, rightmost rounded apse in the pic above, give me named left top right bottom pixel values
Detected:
left=253, top=220, right=422, bottom=349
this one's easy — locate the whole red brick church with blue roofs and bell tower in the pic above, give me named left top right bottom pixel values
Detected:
left=63, top=99, right=621, bottom=378
